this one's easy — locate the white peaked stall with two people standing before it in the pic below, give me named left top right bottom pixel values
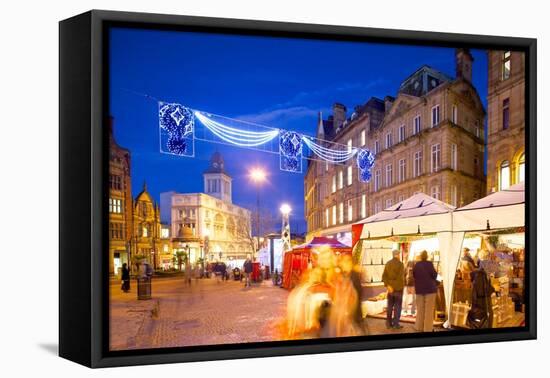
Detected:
left=352, top=193, right=459, bottom=324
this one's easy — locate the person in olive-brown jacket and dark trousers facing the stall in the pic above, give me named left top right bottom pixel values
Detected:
left=382, top=249, right=405, bottom=329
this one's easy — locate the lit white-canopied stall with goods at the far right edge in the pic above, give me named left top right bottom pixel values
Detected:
left=451, top=183, right=525, bottom=327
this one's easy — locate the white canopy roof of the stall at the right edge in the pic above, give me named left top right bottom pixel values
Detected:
left=453, top=183, right=525, bottom=231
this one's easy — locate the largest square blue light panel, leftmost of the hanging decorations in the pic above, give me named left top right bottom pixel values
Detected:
left=159, top=102, right=195, bottom=156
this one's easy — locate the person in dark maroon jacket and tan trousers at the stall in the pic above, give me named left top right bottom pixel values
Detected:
left=413, top=251, right=438, bottom=332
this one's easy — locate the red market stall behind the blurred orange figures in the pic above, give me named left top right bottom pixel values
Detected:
left=283, top=237, right=351, bottom=289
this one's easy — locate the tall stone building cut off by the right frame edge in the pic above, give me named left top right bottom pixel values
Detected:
left=487, top=51, right=525, bottom=193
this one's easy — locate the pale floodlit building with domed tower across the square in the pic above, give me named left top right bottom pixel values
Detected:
left=161, top=153, right=254, bottom=263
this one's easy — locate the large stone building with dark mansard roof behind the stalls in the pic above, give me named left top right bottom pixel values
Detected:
left=305, top=49, right=485, bottom=242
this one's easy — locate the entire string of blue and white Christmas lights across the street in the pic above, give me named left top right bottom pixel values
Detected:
left=159, top=102, right=375, bottom=182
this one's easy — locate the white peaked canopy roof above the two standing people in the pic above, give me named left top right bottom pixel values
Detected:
left=357, top=193, right=455, bottom=239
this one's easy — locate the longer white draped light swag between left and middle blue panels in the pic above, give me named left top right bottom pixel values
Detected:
left=195, top=111, right=279, bottom=147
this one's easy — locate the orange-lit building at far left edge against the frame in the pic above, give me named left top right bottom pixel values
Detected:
left=108, top=118, right=133, bottom=274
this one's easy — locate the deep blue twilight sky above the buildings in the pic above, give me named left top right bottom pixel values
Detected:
left=110, top=28, right=487, bottom=232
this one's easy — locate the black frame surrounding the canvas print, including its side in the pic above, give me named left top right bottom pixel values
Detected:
left=59, top=10, right=537, bottom=368
